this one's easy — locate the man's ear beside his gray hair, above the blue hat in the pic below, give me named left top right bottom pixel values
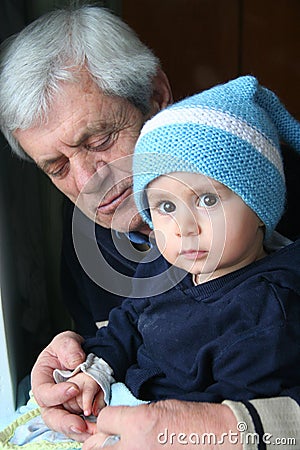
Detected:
left=150, top=68, right=173, bottom=116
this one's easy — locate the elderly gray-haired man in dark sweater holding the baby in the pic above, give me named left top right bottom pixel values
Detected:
left=0, top=7, right=300, bottom=450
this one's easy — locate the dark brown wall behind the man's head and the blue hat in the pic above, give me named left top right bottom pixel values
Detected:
left=122, top=0, right=300, bottom=120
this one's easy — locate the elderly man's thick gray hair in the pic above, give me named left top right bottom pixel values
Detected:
left=0, top=6, right=159, bottom=158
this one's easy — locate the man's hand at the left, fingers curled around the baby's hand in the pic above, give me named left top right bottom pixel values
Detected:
left=31, top=331, right=91, bottom=442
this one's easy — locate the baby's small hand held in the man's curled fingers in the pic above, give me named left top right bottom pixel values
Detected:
left=63, top=372, right=105, bottom=416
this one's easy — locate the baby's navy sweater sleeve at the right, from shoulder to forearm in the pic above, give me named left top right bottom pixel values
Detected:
left=208, top=286, right=300, bottom=400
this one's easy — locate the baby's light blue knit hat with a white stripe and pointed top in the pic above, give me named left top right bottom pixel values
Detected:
left=133, top=76, right=300, bottom=238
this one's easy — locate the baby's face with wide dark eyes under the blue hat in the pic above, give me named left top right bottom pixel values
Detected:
left=147, top=172, right=263, bottom=281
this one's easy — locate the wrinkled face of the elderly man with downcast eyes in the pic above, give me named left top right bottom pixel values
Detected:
left=14, top=74, right=150, bottom=231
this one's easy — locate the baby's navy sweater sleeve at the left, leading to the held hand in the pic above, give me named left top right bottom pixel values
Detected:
left=83, top=299, right=147, bottom=382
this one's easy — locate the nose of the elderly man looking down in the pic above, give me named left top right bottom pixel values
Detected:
left=70, top=152, right=105, bottom=194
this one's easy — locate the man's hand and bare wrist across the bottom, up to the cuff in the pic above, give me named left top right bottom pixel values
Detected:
left=82, top=400, right=242, bottom=450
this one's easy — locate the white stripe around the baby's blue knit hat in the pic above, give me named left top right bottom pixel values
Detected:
left=140, top=106, right=284, bottom=179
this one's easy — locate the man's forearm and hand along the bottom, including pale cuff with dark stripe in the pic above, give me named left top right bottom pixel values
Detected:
left=82, top=397, right=300, bottom=450
